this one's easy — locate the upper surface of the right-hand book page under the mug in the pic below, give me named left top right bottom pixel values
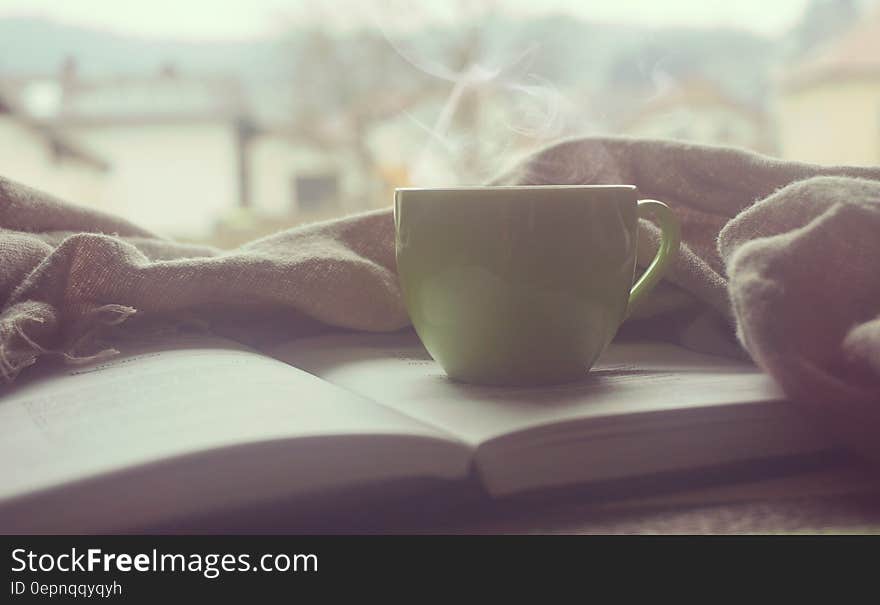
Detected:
left=270, top=332, right=796, bottom=445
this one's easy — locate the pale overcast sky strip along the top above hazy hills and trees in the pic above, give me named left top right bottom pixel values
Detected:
left=0, top=0, right=806, bottom=39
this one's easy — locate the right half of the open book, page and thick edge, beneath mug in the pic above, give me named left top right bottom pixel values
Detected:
left=273, top=333, right=830, bottom=497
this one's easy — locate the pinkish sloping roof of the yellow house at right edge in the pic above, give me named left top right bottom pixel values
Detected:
left=782, top=7, right=880, bottom=88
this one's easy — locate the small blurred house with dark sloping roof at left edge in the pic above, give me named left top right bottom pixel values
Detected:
left=0, top=89, right=109, bottom=207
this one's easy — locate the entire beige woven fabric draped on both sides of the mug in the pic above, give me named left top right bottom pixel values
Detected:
left=0, top=138, right=880, bottom=452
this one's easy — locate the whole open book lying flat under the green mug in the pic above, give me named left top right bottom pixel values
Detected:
left=0, top=333, right=830, bottom=533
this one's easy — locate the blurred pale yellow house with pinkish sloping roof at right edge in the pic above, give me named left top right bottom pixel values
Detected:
left=778, top=9, right=880, bottom=165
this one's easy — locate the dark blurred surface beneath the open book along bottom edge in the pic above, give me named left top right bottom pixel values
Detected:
left=158, top=455, right=880, bottom=534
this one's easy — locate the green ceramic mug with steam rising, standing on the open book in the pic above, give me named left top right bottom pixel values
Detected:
left=394, top=185, right=679, bottom=385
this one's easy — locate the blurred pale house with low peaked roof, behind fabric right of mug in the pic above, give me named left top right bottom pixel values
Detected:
left=620, top=78, right=774, bottom=153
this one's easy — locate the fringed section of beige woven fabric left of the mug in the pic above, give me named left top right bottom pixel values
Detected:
left=0, top=179, right=408, bottom=380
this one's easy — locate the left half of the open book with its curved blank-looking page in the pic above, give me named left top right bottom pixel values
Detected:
left=0, top=338, right=469, bottom=523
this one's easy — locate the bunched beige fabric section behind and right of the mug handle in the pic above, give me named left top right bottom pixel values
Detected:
left=498, top=138, right=880, bottom=459
